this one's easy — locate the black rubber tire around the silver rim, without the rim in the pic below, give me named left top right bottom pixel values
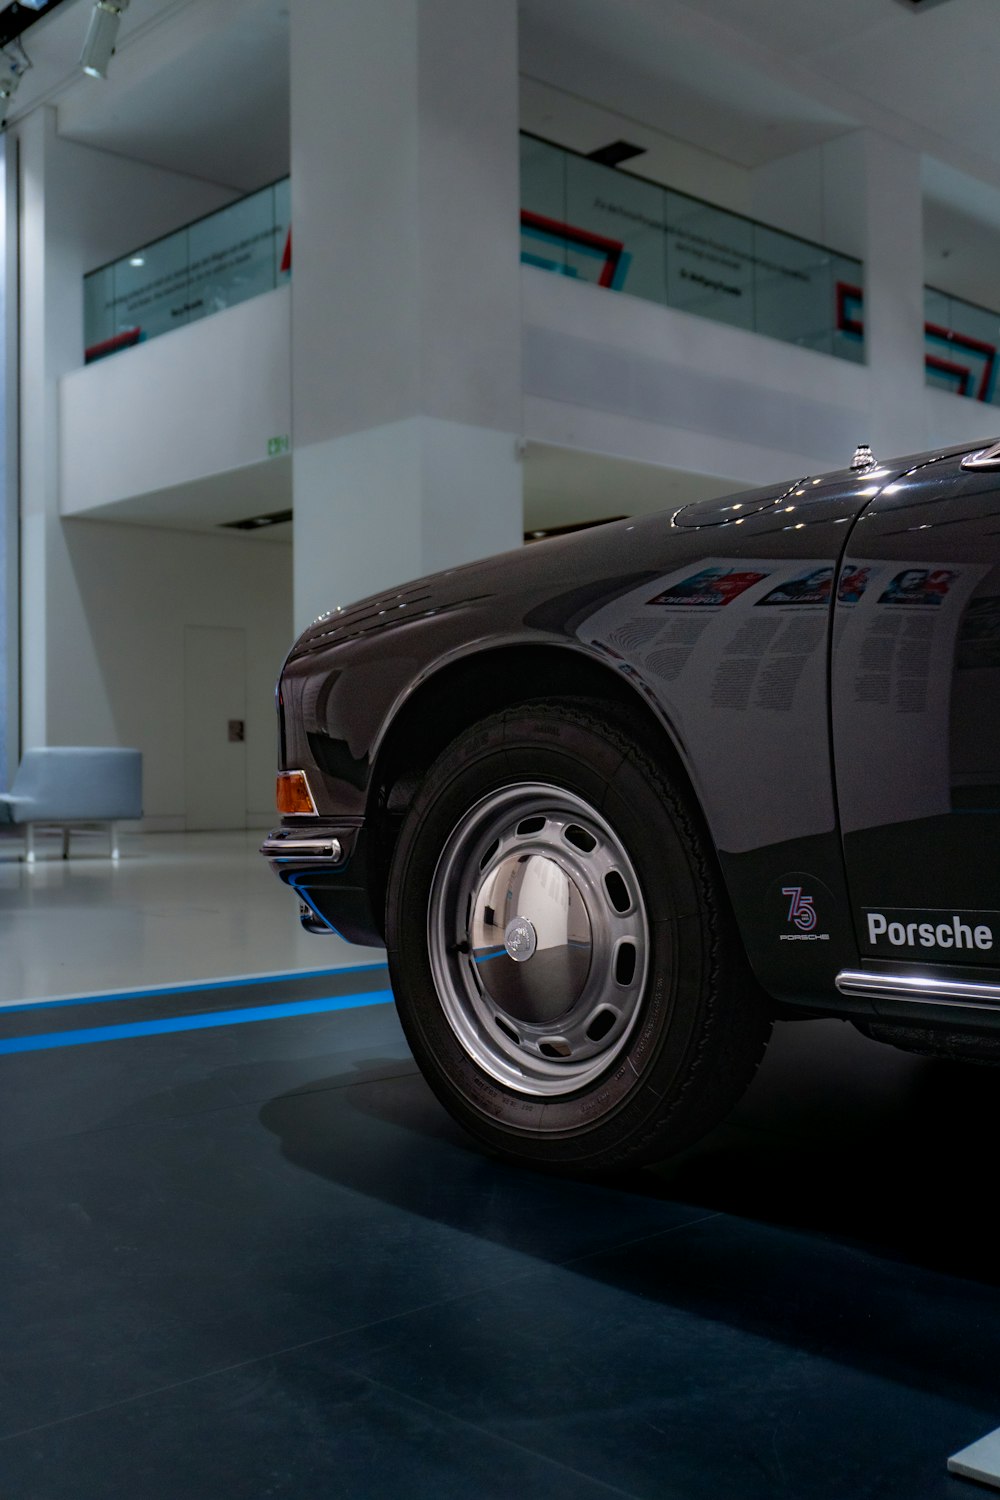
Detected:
left=387, top=707, right=715, bottom=1160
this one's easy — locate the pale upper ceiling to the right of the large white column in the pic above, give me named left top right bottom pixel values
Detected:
left=520, top=0, right=1000, bottom=186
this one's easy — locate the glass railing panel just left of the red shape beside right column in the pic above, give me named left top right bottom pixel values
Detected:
left=754, top=224, right=834, bottom=354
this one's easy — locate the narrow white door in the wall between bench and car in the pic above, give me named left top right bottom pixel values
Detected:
left=184, top=626, right=246, bottom=828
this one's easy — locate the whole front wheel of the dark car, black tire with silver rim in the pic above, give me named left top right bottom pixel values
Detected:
left=387, top=699, right=771, bottom=1172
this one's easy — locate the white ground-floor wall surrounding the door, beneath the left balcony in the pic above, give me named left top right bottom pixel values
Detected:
left=45, top=521, right=292, bottom=828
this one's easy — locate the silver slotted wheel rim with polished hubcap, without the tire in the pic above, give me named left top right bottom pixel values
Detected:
left=427, top=783, right=649, bottom=1097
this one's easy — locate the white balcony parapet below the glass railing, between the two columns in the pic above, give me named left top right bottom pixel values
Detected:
left=522, top=266, right=871, bottom=483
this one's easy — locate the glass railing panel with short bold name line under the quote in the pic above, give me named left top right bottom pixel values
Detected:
left=667, top=192, right=754, bottom=329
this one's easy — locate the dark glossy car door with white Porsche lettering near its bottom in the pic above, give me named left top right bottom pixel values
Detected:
left=832, top=455, right=1000, bottom=995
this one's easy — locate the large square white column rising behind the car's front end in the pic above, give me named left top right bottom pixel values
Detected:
left=291, top=0, right=523, bottom=629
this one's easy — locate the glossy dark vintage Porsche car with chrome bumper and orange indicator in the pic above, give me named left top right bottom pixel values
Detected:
left=262, top=443, right=1000, bottom=1169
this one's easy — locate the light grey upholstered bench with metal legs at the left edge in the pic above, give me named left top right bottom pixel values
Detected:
left=0, top=746, right=142, bottom=863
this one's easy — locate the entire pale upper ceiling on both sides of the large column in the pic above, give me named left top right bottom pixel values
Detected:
left=12, top=0, right=1000, bottom=189
